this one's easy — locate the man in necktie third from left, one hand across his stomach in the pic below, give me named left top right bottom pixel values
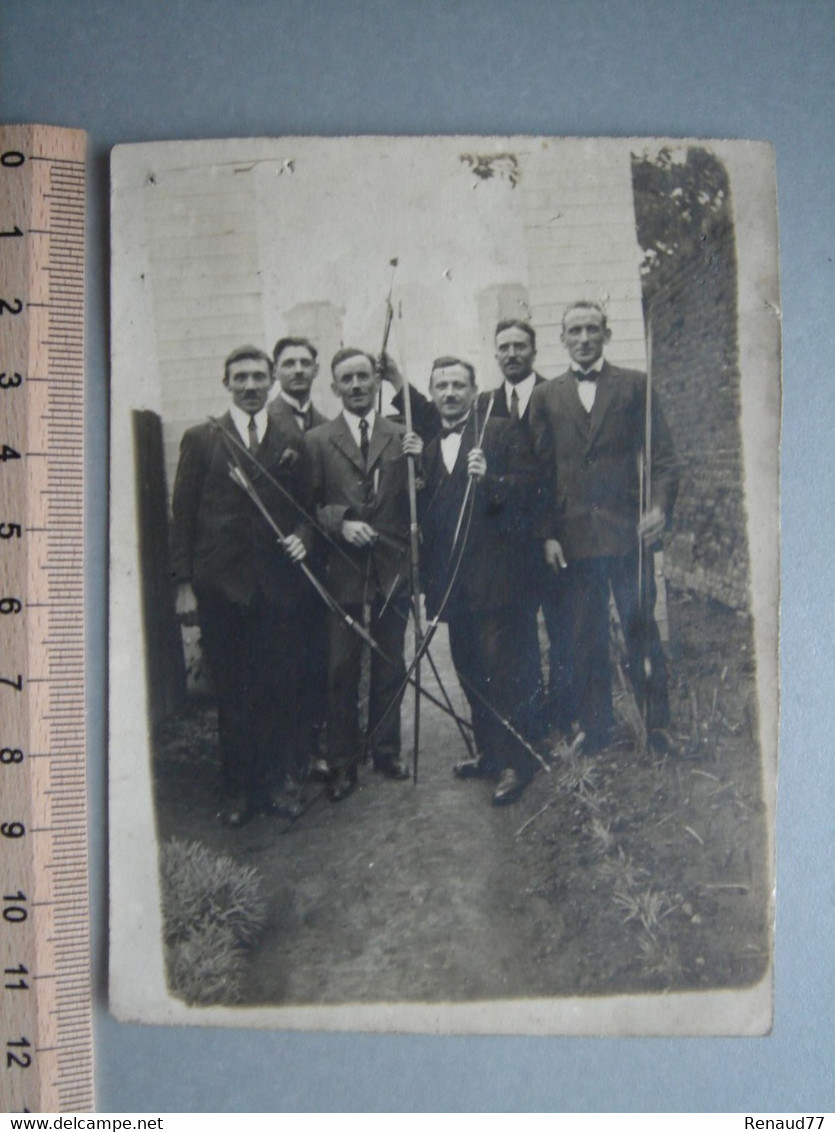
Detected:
left=305, top=348, right=421, bottom=801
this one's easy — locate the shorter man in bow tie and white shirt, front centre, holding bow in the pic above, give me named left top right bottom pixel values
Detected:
left=420, top=357, right=540, bottom=806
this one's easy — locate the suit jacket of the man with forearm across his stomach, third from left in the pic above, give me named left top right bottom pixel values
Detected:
left=304, top=413, right=410, bottom=604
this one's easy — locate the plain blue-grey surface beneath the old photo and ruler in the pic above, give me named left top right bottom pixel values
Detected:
left=0, top=0, right=835, bottom=1113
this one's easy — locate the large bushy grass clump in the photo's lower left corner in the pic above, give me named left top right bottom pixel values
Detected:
left=160, top=838, right=267, bottom=1005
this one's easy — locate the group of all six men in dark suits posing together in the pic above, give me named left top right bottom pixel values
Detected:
left=173, top=301, right=678, bottom=825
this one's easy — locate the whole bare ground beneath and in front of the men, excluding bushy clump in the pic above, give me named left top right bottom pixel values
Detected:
left=155, top=593, right=769, bottom=1004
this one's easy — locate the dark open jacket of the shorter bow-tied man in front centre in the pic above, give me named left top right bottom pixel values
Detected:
left=420, top=415, right=539, bottom=617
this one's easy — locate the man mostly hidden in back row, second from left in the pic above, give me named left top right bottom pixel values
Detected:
left=267, top=337, right=328, bottom=782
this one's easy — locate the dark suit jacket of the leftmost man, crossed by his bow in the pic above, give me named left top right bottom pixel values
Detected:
left=172, top=413, right=310, bottom=606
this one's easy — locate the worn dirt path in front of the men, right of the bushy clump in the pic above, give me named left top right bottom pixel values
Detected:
left=237, top=688, right=560, bottom=1002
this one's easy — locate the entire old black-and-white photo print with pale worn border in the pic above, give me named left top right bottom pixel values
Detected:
left=110, top=137, right=781, bottom=1035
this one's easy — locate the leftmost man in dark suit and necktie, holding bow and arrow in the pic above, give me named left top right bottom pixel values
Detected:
left=171, top=346, right=310, bottom=825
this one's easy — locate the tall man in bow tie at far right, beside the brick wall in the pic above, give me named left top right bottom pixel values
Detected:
left=531, top=300, right=679, bottom=753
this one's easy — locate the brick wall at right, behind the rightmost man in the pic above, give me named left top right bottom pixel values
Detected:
left=649, top=237, right=750, bottom=610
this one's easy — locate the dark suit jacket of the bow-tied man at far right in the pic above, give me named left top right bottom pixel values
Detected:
left=528, top=362, right=679, bottom=561
